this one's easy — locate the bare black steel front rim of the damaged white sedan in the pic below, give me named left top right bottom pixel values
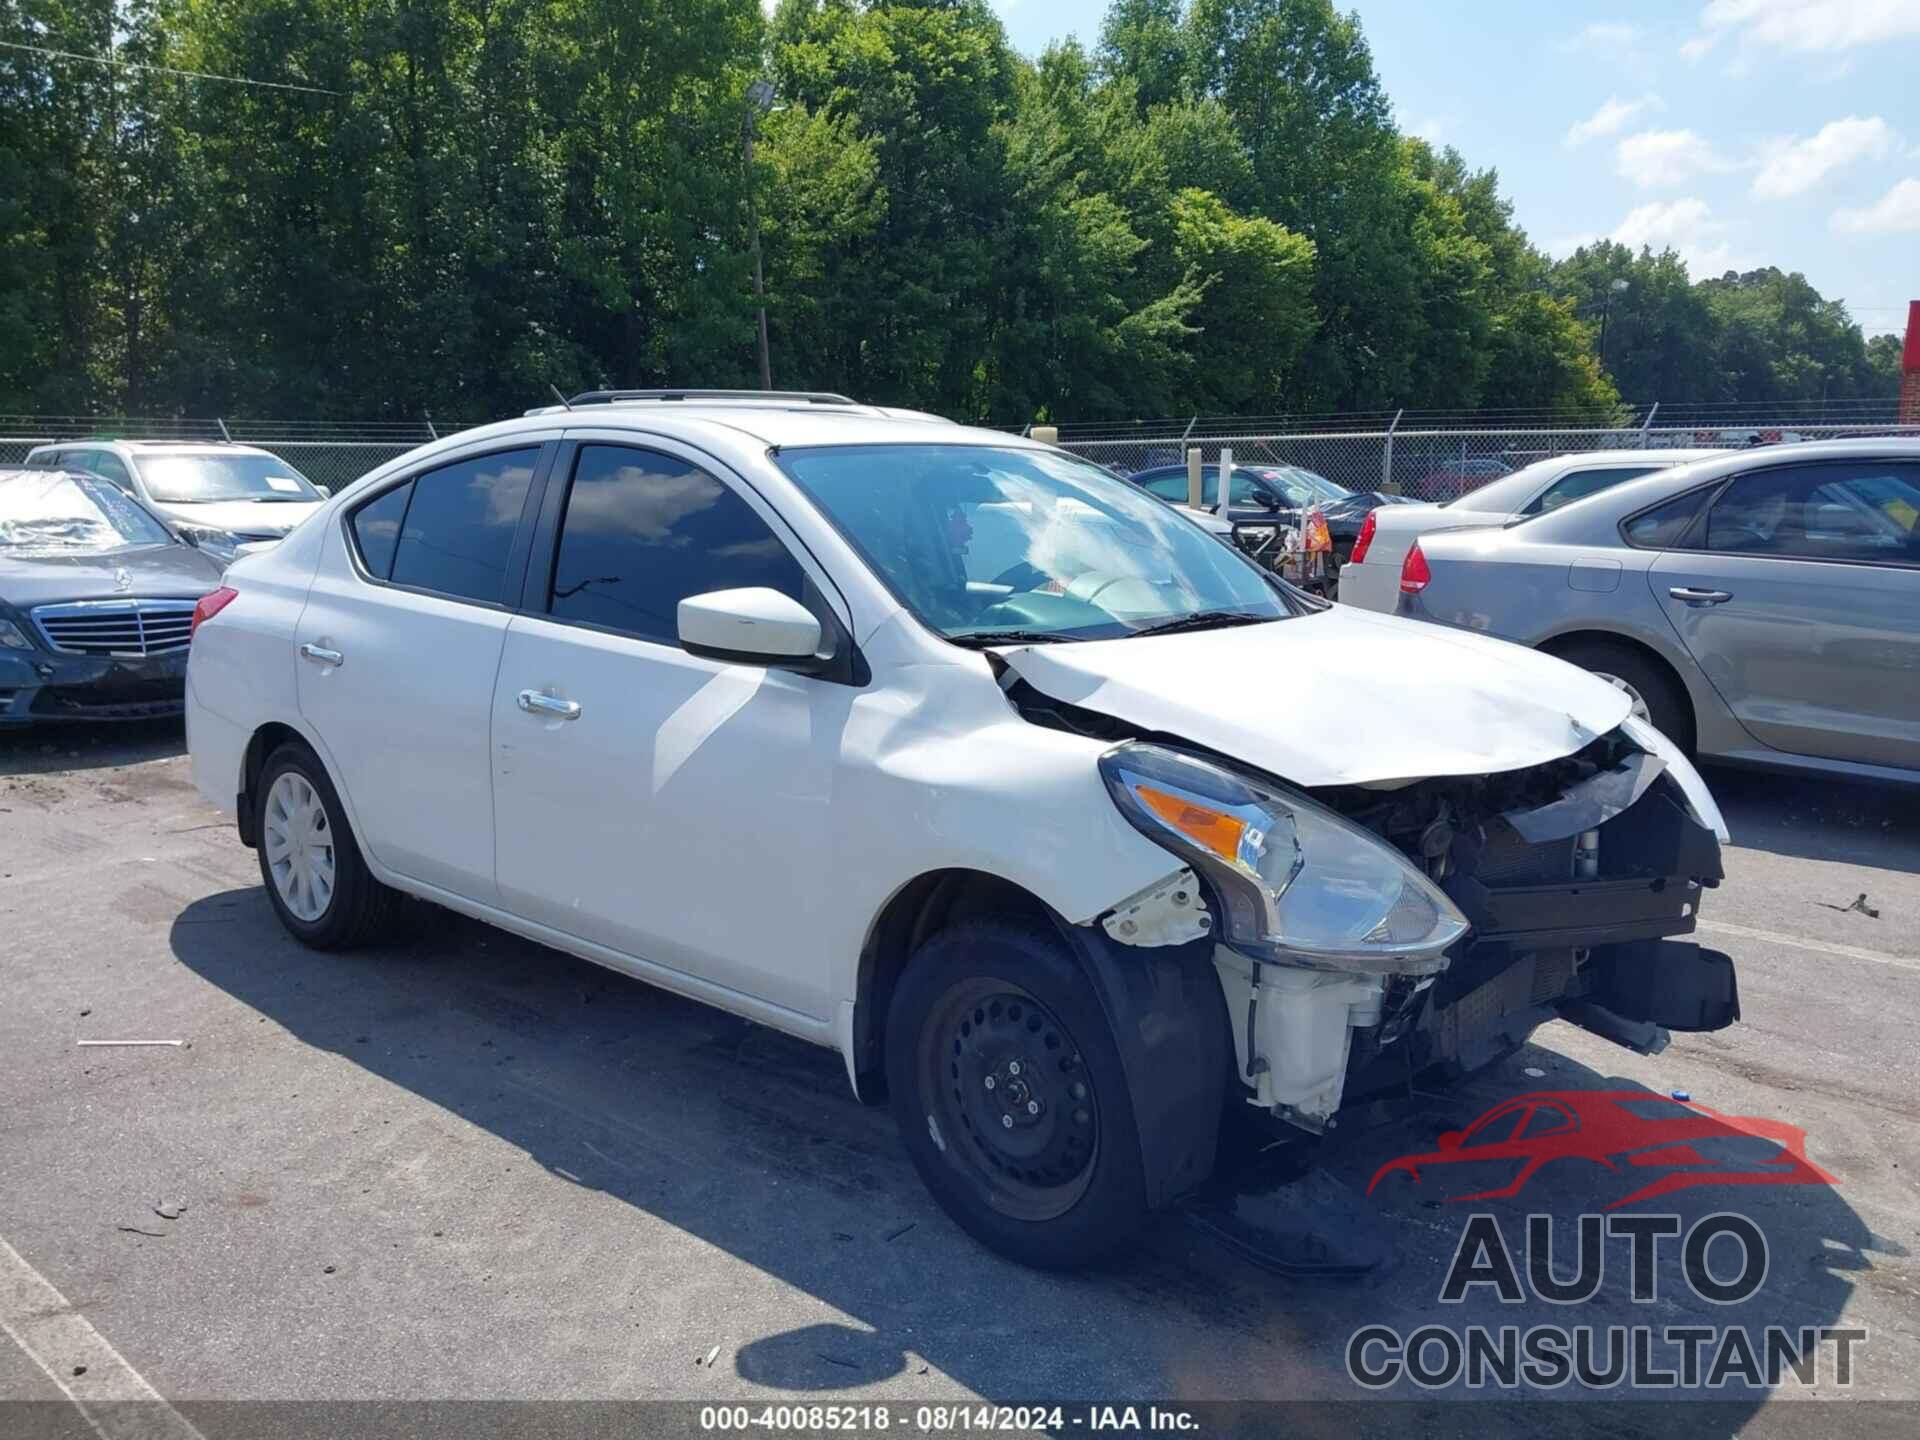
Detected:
left=918, top=977, right=1100, bottom=1221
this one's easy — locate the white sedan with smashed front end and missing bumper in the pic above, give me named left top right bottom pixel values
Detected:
left=188, top=392, right=1738, bottom=1265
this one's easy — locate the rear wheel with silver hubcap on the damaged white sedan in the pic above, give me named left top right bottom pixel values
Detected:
left=253, top=743, right=403, bottom=950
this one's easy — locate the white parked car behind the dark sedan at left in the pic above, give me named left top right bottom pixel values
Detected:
left=27, top=440, right=326, bottom=561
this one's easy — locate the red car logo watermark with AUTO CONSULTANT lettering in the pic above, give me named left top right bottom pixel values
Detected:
left=1346, top=1091, right=1866, bottom=1392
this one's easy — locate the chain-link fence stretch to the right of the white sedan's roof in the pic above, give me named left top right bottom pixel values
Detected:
left=1060, top=422, right=1920, bottom=501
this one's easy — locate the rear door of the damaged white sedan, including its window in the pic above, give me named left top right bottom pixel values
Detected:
left=290, top=436, right=555, bottom=904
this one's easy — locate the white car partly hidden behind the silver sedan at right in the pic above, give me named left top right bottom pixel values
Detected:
left=1338, top=449, right=1726, bottom=614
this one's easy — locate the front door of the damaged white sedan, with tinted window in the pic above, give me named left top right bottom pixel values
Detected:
left=493, top=438, right=852, bottom=1020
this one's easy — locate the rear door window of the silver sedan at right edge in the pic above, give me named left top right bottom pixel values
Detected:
left=1707, top=461, right=1920, bottom=564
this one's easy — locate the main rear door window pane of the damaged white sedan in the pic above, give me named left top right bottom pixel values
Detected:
left=394, top=449, right=540, bottom=603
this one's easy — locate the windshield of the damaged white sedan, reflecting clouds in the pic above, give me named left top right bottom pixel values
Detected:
left=780, top=444, right=1296, bottom=639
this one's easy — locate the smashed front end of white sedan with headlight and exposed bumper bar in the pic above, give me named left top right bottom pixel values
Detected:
left=1102, top=720, right=1740, bottom=1133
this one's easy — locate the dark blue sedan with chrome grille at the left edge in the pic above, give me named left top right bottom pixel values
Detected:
left=0, top=468, right=223, bottom=726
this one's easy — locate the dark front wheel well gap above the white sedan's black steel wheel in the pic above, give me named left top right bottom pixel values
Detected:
left=852, top=870, right=1058, bottom=1104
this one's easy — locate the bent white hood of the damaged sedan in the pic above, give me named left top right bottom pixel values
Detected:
left=996, top=605, right=1632, bottom=785
